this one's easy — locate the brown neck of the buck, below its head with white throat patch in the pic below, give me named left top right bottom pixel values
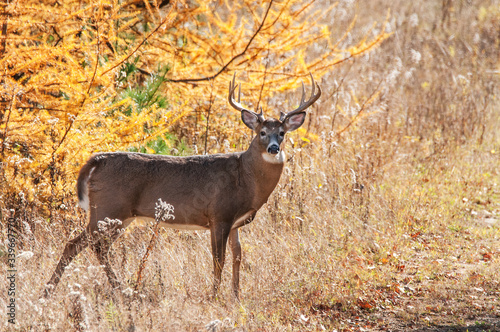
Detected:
left=242, top=139, right=285, bottom=209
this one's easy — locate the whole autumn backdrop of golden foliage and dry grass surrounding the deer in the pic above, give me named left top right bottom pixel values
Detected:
left=0, top=0, right=500, bottom=331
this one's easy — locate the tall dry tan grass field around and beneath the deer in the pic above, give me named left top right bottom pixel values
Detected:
left=0, top=1, right=500, bottom=331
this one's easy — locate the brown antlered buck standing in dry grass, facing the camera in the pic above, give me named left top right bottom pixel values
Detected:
left=45, top=75, right=321, bottom=298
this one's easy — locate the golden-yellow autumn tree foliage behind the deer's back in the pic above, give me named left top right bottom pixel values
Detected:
left=0, top=0, right=389, bottom=209
